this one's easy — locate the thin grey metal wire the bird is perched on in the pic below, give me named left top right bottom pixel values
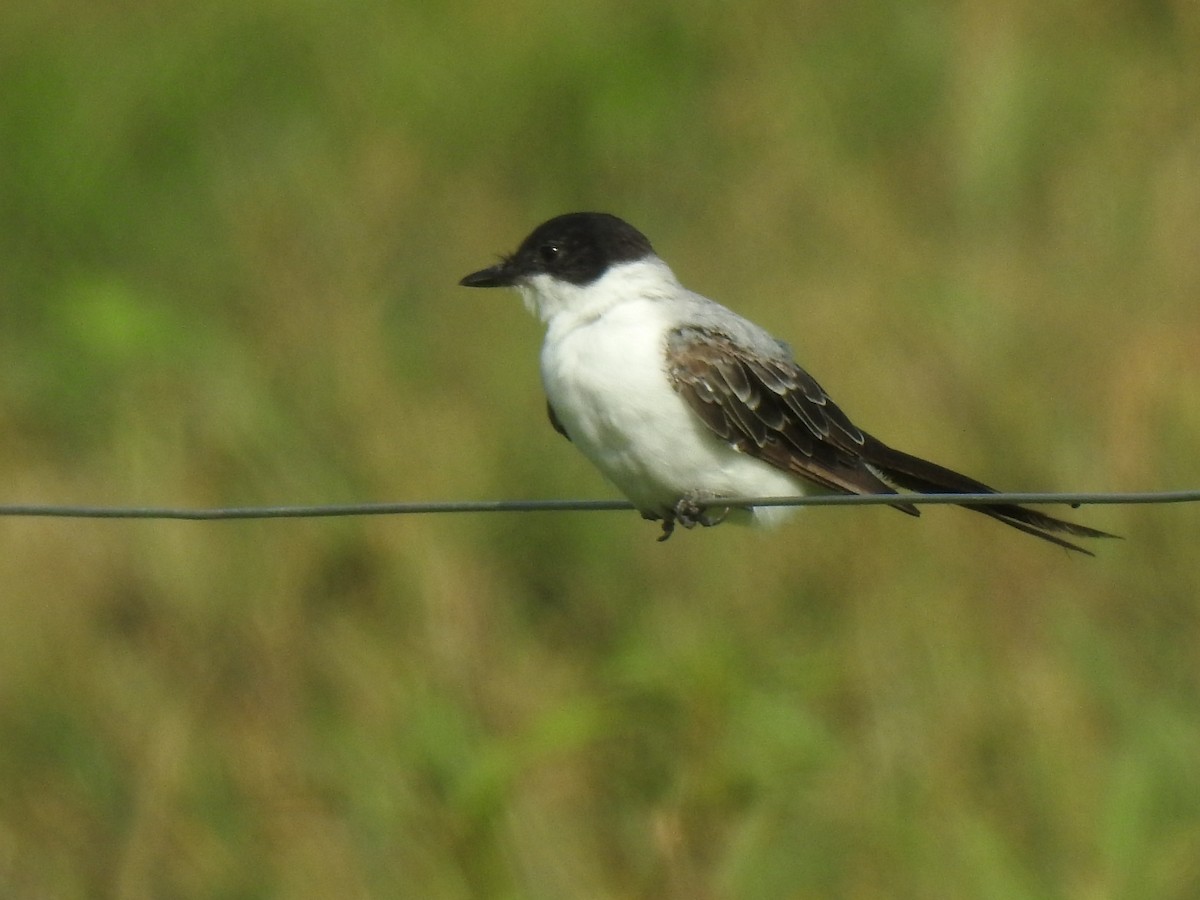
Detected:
left=0, top=490, right=1200, bottom=521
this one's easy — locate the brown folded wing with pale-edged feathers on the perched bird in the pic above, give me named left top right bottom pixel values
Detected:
left=667, top=325, right=919, bottom=516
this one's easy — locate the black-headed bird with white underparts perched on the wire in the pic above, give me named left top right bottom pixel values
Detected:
left=458, top=212, right=1115, bottom=556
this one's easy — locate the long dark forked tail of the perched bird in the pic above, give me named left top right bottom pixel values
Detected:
left=862, top=436, right=1118, bottom=556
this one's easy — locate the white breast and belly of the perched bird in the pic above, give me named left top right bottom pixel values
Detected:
left=541, top=300, right=812, bottom=520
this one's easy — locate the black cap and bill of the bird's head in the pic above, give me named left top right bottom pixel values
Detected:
left=458, top=212, right=654, bottom=288
